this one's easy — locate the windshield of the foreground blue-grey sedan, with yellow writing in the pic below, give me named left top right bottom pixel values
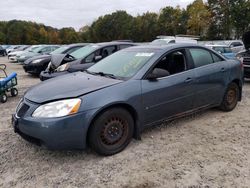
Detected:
left=87, top=51, right=154, bottom=78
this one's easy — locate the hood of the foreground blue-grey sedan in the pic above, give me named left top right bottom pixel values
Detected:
left=24, top=72, right=123, bottom=104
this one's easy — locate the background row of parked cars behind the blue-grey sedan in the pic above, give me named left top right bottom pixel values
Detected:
left=0, top=36, right=248, bottom=81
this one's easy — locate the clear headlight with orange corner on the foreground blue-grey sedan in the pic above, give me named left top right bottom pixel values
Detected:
left=32, top=99, right=81, bottom=118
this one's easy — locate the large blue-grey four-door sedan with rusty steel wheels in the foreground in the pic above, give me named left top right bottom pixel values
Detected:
left=12, top=44, right=243, bottom=155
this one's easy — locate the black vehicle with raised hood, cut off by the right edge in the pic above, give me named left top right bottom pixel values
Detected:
left=236, top=31, right=250, bottom=78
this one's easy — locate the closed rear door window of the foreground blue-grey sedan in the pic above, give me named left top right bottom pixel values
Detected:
left=190, top=48, right=214, bottom=67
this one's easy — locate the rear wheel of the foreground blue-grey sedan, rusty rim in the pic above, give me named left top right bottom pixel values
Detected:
left=220, top=82, right=240, bottom=112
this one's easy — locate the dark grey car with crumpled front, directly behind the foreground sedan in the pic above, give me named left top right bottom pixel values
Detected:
left=40, top=41, right=135, bottom=81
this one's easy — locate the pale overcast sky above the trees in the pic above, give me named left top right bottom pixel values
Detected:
left=0, top=0, right=193, bottom=30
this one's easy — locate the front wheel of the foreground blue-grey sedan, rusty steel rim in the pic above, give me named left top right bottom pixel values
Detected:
left=88, top=108, right=134, bottom=156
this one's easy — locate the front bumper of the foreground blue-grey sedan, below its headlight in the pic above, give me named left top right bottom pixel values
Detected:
left=12, top=100, right=95, bottom=150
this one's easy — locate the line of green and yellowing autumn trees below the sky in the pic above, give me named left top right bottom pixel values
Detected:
left=0, top=0, right=250, bottom=44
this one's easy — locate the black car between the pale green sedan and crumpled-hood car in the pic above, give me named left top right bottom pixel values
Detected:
left=23, top=44, right=87, bottom=75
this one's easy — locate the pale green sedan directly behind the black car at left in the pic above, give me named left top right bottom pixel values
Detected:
left=16, top=45, right=60, bottom=63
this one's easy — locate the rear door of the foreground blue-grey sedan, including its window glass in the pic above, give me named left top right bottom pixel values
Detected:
left=189, top=48, right=229, bottom=108
